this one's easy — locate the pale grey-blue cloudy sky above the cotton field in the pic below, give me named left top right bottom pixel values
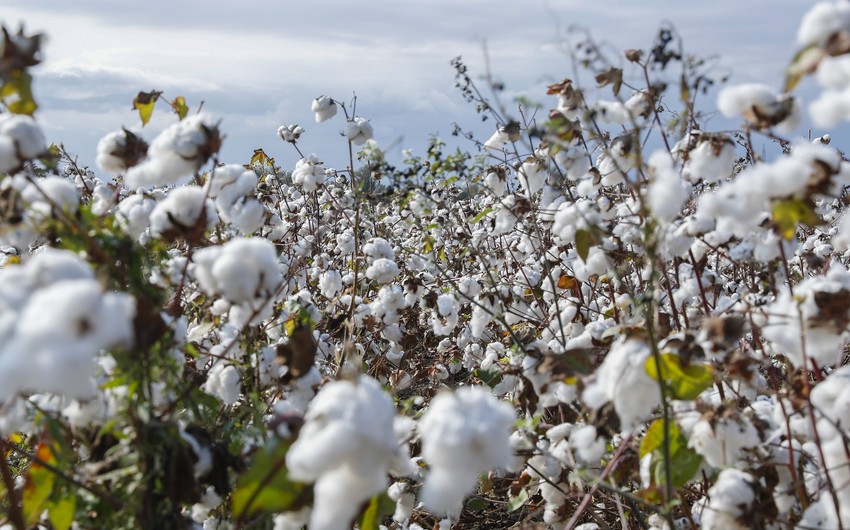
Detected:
left=0, top=0, right=812, bottom=167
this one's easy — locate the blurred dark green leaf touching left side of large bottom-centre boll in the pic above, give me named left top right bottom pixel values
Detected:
left=232, top=441, right=311, bottom=517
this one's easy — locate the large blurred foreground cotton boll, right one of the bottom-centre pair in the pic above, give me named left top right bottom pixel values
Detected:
left=419, top=387, right=516, bottom=516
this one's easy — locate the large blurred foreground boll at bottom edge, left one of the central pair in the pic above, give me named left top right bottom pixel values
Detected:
left=286, top=376, right=398, bottom=530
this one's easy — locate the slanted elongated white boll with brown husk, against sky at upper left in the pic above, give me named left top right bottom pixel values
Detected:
left=124, top=114, right=221, bottom=190
